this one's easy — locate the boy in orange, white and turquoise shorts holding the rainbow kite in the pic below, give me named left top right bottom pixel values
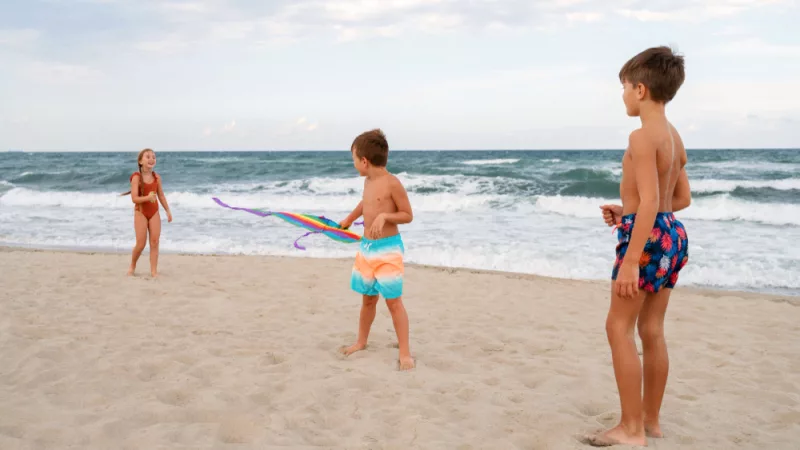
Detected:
left=339, top=129, right=414, bottom=370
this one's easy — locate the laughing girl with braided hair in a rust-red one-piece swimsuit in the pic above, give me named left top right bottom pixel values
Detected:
left=122, top=148, right=172, bottom=278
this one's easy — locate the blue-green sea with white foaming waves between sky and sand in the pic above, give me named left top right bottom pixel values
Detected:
left=0, top=149, right=800, bottom=295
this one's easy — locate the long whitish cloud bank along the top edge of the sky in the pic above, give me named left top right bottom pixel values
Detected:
left=23, top=0, right=795, bottom=54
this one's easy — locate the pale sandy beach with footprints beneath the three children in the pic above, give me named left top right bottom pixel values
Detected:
left=0, top=249, right=800, bottom=449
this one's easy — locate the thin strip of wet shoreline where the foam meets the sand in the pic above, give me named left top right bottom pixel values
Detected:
left=0, top=244, right=800, bottom=306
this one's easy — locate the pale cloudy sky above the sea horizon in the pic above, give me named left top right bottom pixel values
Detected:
left=0, top=0, right=800, bottom=151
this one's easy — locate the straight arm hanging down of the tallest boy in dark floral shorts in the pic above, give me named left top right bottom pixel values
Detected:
left=617, top=130, right=659, bottom=297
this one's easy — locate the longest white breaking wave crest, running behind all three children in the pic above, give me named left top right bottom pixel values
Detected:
left=7, top=181, right=800, bottom=226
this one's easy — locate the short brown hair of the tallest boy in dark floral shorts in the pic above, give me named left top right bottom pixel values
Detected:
left=619, top=46, right=686, bottom=103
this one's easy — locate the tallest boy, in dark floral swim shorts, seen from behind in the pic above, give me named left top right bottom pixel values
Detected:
left=589, top=47, right=691, bottom=446
